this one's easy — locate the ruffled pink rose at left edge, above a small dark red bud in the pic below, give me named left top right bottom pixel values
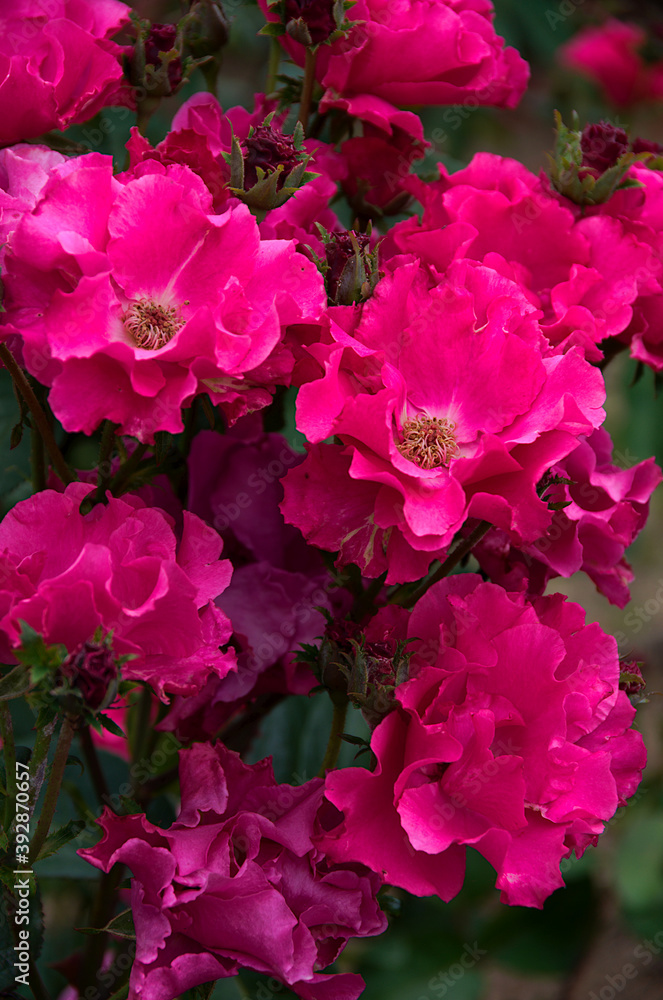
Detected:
left=0, top=483, right=236, bottom=698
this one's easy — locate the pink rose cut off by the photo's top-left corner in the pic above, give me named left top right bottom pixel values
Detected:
left=0, top=0, right=129, bottom=145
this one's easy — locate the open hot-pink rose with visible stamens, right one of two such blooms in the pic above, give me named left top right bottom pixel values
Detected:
left=281, top=258, right=604, bottom=583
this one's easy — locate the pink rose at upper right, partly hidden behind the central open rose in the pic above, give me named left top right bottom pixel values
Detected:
left=383, top=153, right=663, bottom=361
